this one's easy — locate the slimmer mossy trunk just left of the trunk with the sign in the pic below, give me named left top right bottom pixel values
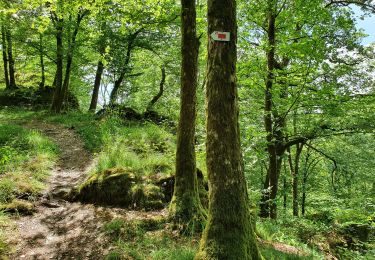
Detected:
left=169, top=0, right=205, bottom=232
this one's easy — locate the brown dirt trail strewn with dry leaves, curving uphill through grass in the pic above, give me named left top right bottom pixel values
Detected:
left=5, top=121, right=164, bottom=259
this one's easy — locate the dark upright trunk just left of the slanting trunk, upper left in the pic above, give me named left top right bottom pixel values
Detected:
left=51, top=20, right=64, bottom=113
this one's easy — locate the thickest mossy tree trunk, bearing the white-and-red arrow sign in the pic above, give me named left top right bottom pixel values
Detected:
left=196, top=0, right=261, bottom=260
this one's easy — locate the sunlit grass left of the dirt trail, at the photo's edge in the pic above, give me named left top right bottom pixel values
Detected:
left=0, top=118, right=58, bottom=255
